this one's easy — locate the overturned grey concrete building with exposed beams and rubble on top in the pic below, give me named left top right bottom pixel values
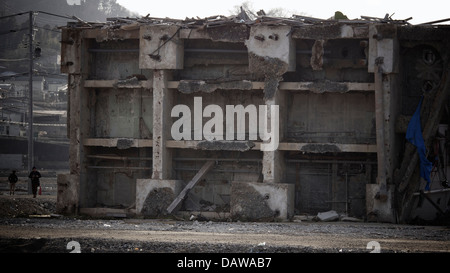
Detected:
left=57, top=11, right=450, bottom=222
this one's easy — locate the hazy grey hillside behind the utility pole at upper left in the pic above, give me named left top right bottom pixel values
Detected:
left=0, top=0, right=137, bottom=75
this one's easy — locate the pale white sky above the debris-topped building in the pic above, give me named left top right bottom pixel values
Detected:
left=117, top=0, right=450, bottom=24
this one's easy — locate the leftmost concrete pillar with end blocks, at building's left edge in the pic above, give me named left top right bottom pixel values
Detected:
left=57, top=30, right=96, bottom=210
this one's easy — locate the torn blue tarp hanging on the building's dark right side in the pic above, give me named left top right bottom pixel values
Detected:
left=406, top=96, right=433, bottom=190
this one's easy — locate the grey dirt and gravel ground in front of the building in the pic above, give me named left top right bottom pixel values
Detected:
left=0, top=192, right=450, bottom=254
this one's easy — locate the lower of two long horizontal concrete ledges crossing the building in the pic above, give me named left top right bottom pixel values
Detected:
left=84, top=138, right=377, bottom=153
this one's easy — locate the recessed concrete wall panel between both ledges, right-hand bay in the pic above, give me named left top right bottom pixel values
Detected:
left=286, top=92, right=376, bottom=144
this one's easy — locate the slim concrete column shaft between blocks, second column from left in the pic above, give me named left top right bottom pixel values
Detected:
left=152, top=70, right=173, bottom=179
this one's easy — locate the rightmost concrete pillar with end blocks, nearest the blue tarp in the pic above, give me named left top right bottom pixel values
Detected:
left=366, top=25, right=401, bottom=222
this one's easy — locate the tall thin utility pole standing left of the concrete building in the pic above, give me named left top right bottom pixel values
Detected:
left=28, top=11, right=34, bottom=194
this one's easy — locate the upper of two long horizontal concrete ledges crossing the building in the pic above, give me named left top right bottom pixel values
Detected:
left=84, top=80, right=375, bottom=93
